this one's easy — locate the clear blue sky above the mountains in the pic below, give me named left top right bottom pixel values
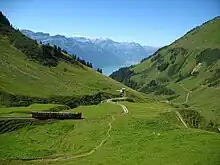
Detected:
left=0, top=0, right=220, bottom=46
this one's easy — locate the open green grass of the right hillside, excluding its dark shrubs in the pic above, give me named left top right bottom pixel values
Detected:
left=116, top=17, right=220, bottom=124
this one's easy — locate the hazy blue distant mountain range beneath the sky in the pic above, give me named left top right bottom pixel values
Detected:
left=21, top=30, right=158, bottom=68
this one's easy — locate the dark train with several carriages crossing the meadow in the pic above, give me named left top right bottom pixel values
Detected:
left=31, top=111, right=82, bottom=120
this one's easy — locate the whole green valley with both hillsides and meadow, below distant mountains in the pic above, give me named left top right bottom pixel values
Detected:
left=0, top=9, right=220, bottom=165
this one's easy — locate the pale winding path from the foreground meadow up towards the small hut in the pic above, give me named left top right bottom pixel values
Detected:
left=25, top=98, right=128, bottom=162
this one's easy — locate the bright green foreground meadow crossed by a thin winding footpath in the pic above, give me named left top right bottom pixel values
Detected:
left=0, top=103, right=220, bottom=165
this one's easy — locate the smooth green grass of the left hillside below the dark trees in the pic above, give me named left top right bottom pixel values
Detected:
left=0, top=38, right=148, bottom=102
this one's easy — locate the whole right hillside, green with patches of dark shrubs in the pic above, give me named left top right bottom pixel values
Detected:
left=110, top=17, right=220, bottom=124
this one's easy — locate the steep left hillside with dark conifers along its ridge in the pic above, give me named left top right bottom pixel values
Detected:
left=0, top=11, right=149, bottom=107
